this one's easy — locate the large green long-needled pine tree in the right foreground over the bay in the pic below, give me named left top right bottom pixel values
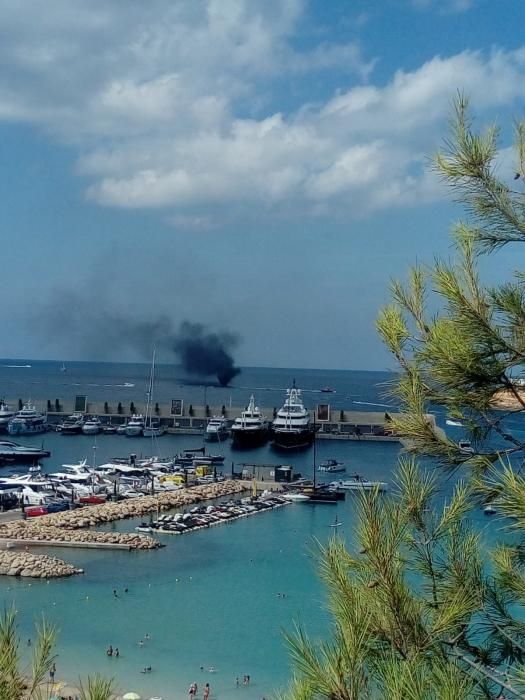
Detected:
left=283, top=96, right=525, bottom=700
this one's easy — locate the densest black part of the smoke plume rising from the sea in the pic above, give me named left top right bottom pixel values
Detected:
left=173, top=321, right=241, bottom=386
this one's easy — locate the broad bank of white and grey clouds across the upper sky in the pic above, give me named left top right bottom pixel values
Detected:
left=0, top=0, right=525, bottom=219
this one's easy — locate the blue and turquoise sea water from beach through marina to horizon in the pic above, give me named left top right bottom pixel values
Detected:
left=0, top=359, right=525, bottom=700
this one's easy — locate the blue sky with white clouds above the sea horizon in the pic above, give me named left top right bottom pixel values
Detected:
left=0, top=0, right=525, bottom=369
